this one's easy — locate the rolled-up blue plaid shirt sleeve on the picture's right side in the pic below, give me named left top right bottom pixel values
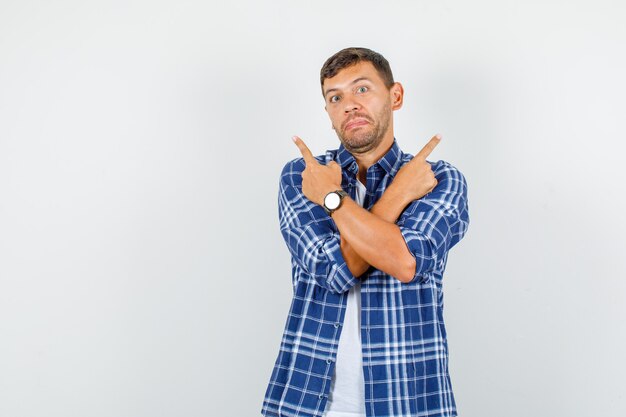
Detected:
left=398, top=161, right=469, bottom=282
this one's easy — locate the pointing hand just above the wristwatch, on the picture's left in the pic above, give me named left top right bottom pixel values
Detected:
left=293, top=136, right=341, bottom=206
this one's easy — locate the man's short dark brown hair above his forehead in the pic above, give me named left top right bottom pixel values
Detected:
left=320, top=47, right=394, bottom=95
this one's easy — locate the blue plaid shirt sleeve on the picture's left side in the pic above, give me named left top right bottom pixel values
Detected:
left=278, top=158, right=358, bottom=293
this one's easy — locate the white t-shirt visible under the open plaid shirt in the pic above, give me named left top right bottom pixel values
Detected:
left=322, top=180, right=366, bottom=417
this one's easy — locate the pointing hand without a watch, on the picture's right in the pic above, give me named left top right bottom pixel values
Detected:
left=388, top=135, right=441, bottom=204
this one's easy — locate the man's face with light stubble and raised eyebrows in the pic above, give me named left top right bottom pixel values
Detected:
left=323, top=61, right=401, bottom=153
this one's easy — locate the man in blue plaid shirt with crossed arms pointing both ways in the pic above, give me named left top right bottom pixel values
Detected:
left=261, top=48, right=469, bottom=417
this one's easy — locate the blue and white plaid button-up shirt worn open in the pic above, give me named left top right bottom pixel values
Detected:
left=261, top=138, right=469, bottom=417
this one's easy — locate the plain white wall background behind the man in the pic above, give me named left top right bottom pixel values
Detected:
left=0, top=0, right=626, bottom=417
